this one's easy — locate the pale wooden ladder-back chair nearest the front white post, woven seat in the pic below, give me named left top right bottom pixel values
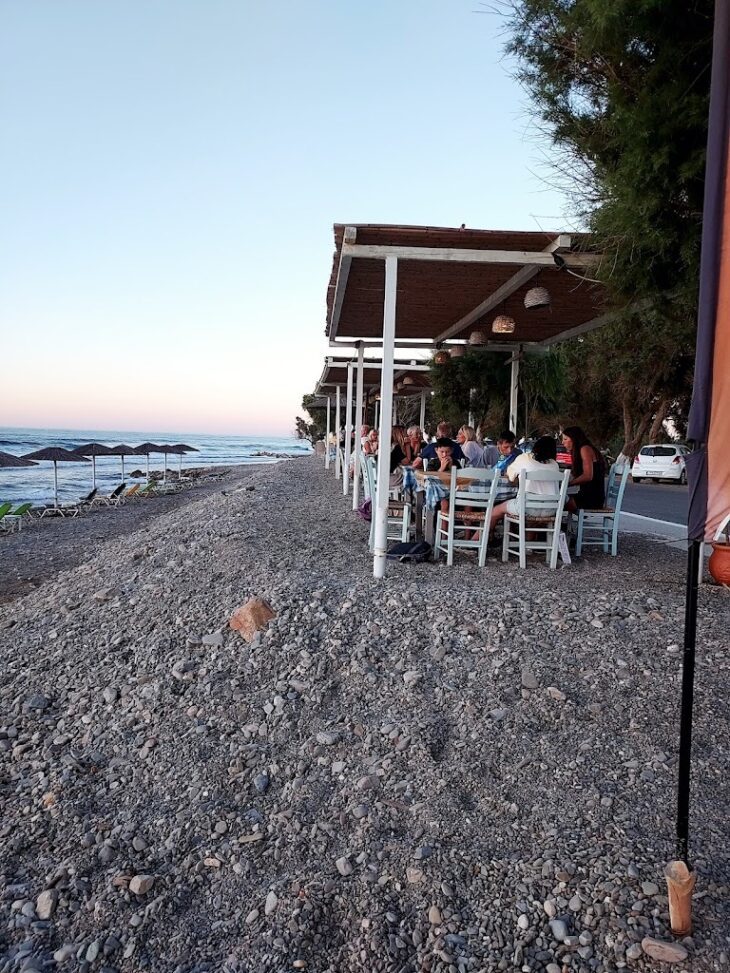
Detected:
left=433, top=467, right=500, bottom=568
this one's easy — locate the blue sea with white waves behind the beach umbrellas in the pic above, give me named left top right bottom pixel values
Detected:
left=0, top=427, right=312, bottom=506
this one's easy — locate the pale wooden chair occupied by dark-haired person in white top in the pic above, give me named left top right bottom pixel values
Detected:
left=502, top=469, right=570, bottom=570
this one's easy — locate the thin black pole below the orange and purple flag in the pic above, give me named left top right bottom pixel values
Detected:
left=677, top=541, right=701, bottom=865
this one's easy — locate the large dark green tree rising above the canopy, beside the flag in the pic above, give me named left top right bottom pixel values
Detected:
left=507, top=0, right=713, bottom=452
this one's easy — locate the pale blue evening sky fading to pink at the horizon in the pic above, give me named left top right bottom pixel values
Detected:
left=0, top=0, right=569, bottom=435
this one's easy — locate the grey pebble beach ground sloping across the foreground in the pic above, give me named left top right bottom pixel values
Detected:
left=0, top=459, right=730, bottom=973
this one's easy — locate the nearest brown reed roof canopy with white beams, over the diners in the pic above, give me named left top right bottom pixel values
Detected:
left=327, top=224, right=608, bottom=349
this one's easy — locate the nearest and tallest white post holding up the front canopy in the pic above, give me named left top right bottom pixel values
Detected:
left=371, top=257, right=398, bottom=578
